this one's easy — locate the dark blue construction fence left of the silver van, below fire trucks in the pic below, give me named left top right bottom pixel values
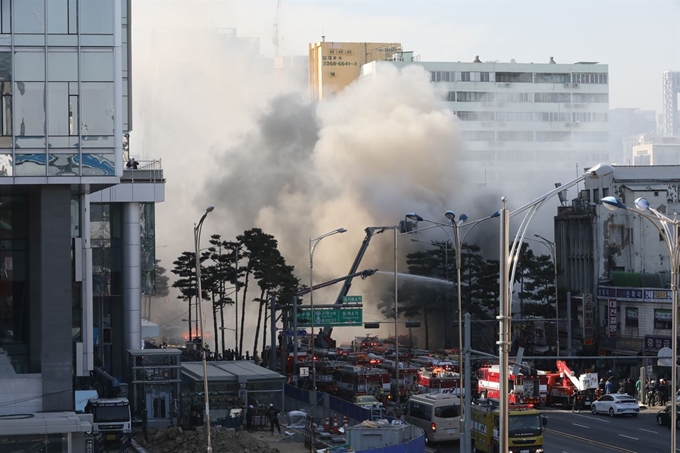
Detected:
left=283, top=384, right=371, bottom=423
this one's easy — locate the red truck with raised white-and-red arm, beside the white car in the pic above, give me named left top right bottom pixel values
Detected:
left=546, top=360, right=597, bottom=407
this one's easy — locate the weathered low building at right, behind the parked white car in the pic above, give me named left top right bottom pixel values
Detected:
left=555, top=165, right=680, bottom=362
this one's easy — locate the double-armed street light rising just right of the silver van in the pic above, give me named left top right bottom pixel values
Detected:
left=406, top=211, right=500, bottom=451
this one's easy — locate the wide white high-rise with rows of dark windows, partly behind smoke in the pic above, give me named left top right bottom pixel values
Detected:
left=361, top=55, right=611, bottom=183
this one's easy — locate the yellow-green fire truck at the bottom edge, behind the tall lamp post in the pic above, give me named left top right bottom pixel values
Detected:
left=470, top=399, right=548, bottom=453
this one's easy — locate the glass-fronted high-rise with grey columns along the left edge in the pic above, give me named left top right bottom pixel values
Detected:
left=0, top=0, right=164, bottom=444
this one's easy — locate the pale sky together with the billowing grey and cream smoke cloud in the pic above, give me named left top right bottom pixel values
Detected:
left=130, top=0, right=680, bottom=349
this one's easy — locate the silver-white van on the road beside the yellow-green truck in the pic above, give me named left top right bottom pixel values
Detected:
left=404, top=393, right=460, bottom=444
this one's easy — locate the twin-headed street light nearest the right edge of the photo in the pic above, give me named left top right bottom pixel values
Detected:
left=601, top=197, right=680, bottom=453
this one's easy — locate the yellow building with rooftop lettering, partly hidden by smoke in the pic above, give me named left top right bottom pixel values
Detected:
left=309, top=41, right=402, bottom=101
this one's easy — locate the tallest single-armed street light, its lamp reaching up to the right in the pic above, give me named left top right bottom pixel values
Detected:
left=497, top=164, right=612, bottom=452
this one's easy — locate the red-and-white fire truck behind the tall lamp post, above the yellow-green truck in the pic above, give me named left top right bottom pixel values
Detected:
left=477, top=365, right=548, bottom=405
